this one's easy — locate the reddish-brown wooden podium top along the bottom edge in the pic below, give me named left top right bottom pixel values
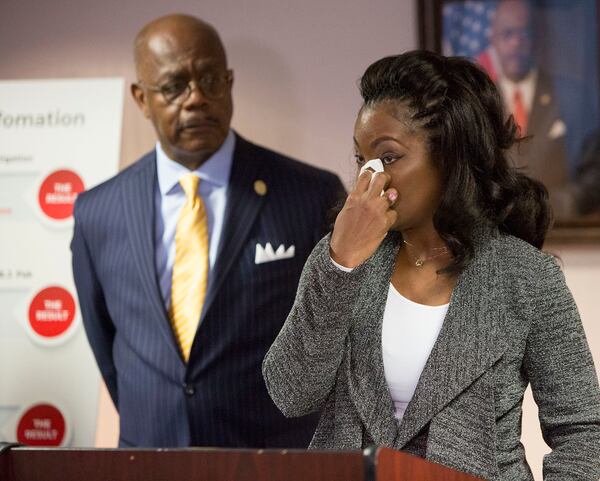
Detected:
left=0, top=446, right=479, bottom=481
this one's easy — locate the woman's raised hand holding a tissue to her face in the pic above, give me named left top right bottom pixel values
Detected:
left=330, top=170, right=398, bottom=268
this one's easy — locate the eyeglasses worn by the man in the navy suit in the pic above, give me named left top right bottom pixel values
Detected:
left=138, top=70, right=233, bottom=105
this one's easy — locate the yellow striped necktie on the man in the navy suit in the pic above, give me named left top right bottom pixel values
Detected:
left=171, top=173, right=208, bottom=361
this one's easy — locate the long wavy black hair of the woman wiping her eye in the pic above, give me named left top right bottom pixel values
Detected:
left=360, top=50, right=552, bottom=274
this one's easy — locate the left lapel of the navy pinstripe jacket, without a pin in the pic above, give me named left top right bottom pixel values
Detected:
left=121, top=152, right=181, bottom=358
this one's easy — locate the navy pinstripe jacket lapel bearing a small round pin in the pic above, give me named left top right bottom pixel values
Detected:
left=202, top=135, right=269, bottom=318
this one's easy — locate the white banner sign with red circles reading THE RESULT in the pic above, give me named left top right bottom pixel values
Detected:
left=0, top=79, right=124, bottom=446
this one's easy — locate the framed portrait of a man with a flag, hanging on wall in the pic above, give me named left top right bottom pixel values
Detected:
left=418, top=0, right=600, bottom=243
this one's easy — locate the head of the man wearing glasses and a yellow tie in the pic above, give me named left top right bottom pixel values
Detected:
left=131, top=15, right=233, bottom=170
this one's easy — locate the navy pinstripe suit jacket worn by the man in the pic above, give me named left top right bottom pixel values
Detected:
left=71, top=136, right=343, bottom=448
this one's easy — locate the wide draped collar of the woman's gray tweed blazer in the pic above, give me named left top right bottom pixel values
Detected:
left=349, top=228, right=506, bottom=449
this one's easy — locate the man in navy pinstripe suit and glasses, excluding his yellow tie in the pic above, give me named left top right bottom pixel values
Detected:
left=72, top=15, right=343, bottom=448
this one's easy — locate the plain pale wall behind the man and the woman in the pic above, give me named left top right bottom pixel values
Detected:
left=0, top=0, right=600, bottom=479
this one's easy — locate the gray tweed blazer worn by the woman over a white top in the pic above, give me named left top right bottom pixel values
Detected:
left=263, top=230, right=600, bottom=481
